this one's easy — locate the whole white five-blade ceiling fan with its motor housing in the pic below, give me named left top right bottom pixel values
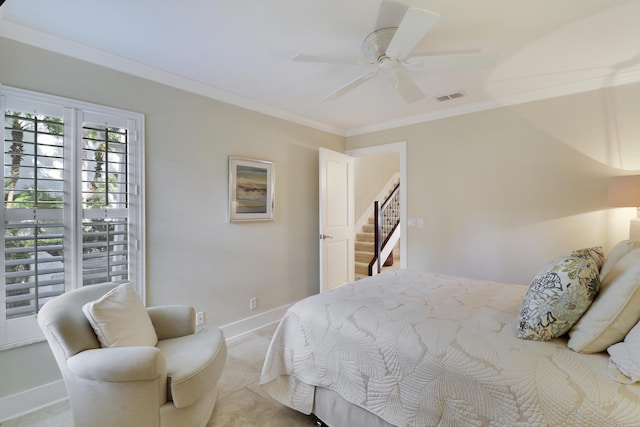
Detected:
left=292, top=8, right=496, bottom=104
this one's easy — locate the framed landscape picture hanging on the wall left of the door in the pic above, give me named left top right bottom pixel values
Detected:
left=229, top=156, right=275, bottom=222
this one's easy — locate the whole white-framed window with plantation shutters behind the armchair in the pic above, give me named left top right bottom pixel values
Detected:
left=0, top=87, right=144, bottom=348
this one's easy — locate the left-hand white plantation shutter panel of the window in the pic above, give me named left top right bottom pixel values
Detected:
left=4, top=100, right=65, bottom=319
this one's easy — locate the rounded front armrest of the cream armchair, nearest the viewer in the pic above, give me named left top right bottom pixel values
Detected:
left=67, top=347, right=167, bottom=382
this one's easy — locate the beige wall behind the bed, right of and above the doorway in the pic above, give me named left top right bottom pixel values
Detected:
left=347, top=85, right=640, bottom=284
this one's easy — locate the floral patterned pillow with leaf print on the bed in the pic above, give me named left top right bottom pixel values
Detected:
left=518, top=254, right=600, bottom=341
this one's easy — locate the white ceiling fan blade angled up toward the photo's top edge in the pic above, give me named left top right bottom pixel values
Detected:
left=386, top=7, right=440, bottom=59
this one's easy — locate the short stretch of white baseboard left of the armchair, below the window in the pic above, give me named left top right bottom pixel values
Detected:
left=0, top=380, right=68, bottom=424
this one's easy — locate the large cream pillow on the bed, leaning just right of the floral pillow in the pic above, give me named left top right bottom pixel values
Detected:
left=568, top=249, right=640, bottom=353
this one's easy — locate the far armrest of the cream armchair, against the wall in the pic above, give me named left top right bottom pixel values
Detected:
left=147, top=305, right=196, bottom=340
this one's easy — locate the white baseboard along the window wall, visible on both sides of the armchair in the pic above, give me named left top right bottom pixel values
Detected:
left=0, top=304, right=291, bottom=424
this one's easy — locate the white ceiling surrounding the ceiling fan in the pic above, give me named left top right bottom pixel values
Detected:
left=0, top=0, right=640, bottom=135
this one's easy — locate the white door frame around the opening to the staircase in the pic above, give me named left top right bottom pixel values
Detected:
left=345, top=141, right=409, bottom=268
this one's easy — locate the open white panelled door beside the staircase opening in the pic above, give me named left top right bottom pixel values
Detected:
left=319, top=148, right=355, bottom=292
